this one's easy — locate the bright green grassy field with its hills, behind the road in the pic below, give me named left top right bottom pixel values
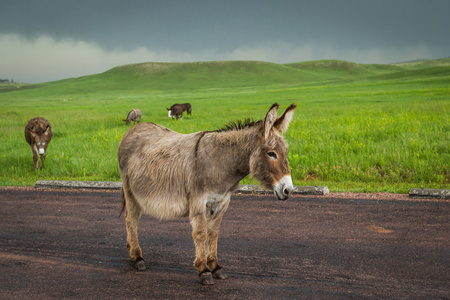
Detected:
left=0, top=59, right=450, bottom=193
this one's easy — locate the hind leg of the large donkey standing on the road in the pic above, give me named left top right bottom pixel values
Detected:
left=122, top=184, right=145, bottom=271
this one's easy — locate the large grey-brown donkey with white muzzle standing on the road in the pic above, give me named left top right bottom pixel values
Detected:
left=118, top=104, right=295, bottom=284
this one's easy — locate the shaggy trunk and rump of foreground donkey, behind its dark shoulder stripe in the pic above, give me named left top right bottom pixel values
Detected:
left=118, top=123, right=199, bottom=219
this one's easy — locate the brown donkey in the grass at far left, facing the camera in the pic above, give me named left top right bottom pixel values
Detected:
left=25, top=117, right=53, bottom=169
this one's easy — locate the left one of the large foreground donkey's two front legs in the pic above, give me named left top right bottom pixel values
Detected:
left=189, top=209, right=214, bottom=285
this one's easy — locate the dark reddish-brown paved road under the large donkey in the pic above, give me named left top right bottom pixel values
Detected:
left=0, top=188, right=450, bottom=299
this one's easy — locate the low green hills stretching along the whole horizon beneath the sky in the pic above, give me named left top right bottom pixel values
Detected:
left=0, top=59, right=450, bottom=99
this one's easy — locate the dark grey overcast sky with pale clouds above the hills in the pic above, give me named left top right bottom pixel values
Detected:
left=0, top=0, right=450, bottom=83
